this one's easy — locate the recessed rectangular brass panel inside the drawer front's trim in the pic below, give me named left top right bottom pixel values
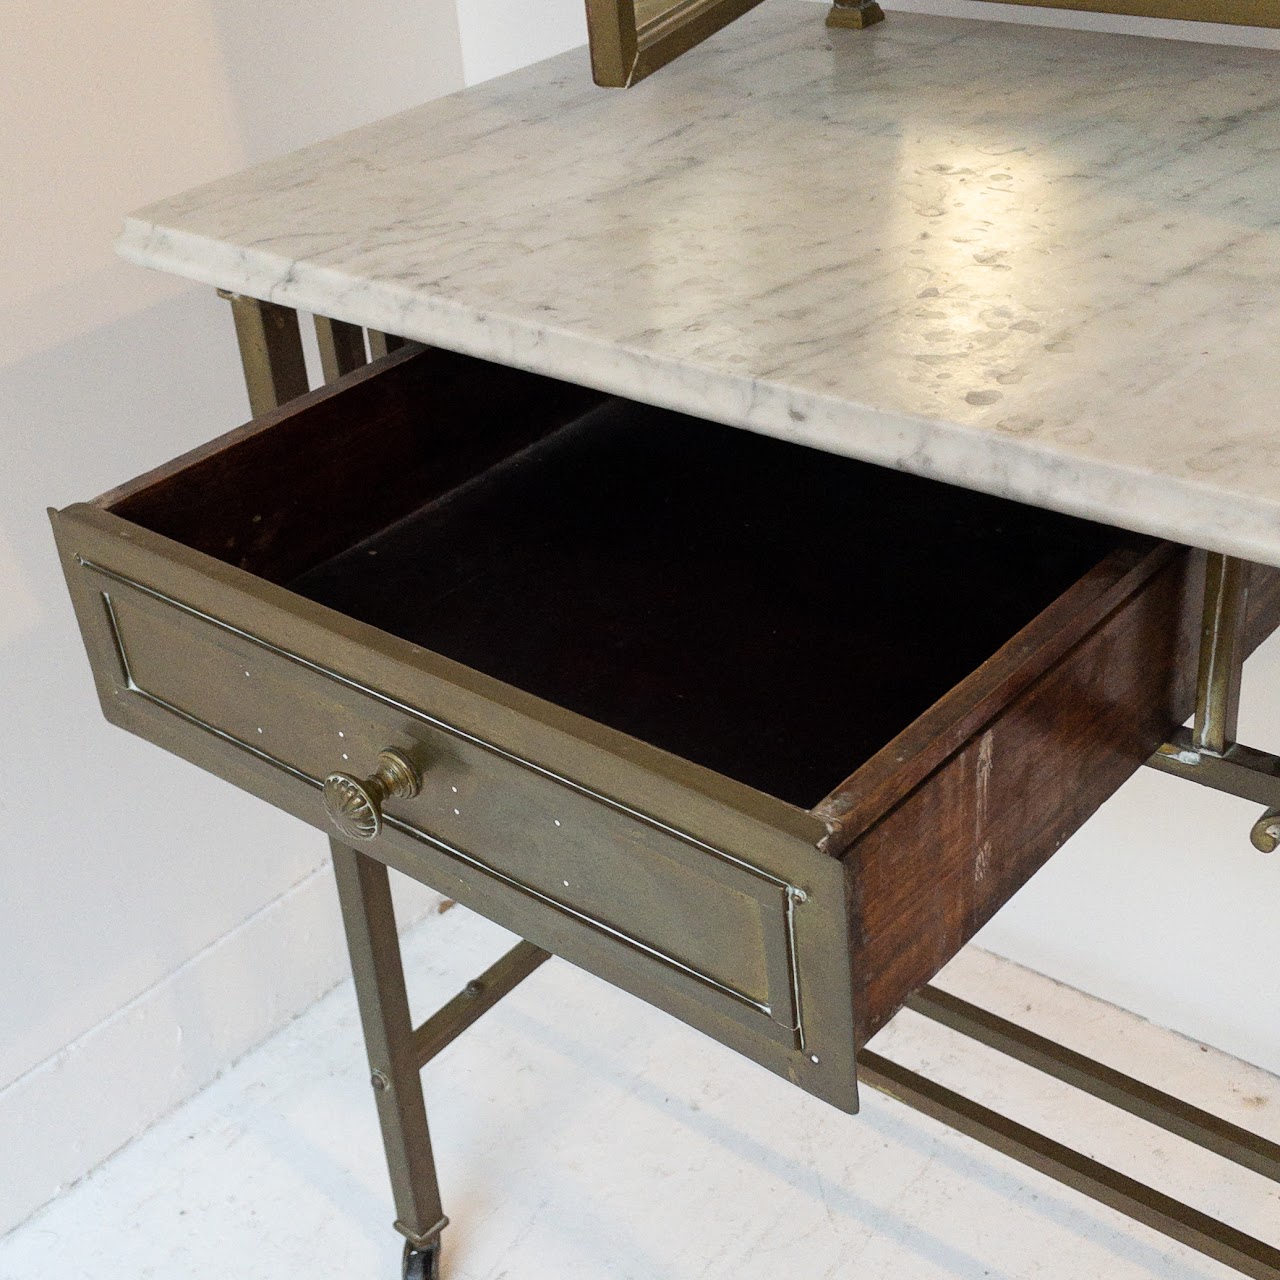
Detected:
left=86, top=566, right=795, bottom=1030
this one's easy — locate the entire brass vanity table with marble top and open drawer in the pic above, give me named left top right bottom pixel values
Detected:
left=52, top=0, right=1280, bottom=1277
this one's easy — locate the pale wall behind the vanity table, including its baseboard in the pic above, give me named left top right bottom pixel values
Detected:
left=0, top=0, right=1280, bottom=1231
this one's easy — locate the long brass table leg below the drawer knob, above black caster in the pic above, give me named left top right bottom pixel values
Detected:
left=330, top=841, right=448, bottom=1248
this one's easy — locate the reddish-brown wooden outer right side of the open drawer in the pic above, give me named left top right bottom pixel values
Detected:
left=845, top=544, right=1280, bottom=1043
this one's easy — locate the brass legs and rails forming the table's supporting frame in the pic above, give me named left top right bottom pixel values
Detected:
left=224, top=302, right=1280, bottom=1280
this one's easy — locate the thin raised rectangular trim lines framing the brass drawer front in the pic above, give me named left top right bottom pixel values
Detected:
left=90, top=556, right=808, bottom=1034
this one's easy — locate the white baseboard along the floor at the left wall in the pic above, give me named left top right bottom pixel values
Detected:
left=0, top=863, right=440, bottom=1235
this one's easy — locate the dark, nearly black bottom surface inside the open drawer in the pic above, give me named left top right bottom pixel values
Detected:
left=291, top=399, right=1123, bottom=809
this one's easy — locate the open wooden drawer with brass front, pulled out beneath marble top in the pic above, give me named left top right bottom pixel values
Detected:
left=52, top=348, right=1276, bottom=1110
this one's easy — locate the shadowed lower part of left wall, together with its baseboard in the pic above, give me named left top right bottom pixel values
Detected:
left=0, top=282, right=346, bottom=1235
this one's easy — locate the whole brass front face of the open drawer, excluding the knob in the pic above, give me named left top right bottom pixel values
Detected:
left=60, top=529, right=856, bottom=1110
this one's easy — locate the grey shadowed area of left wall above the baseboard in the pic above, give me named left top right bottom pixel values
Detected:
left=0, top=291, right=324, bottom=1088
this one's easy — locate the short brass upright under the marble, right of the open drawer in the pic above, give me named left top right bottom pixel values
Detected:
left=1192, top=552, right=1249, bottom=755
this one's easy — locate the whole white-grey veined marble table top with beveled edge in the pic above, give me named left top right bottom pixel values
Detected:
left=119, top=0, right=1280, bottom=564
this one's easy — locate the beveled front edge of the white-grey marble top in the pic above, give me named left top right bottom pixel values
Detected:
left=116, top=216, right=1280, bottom=566
